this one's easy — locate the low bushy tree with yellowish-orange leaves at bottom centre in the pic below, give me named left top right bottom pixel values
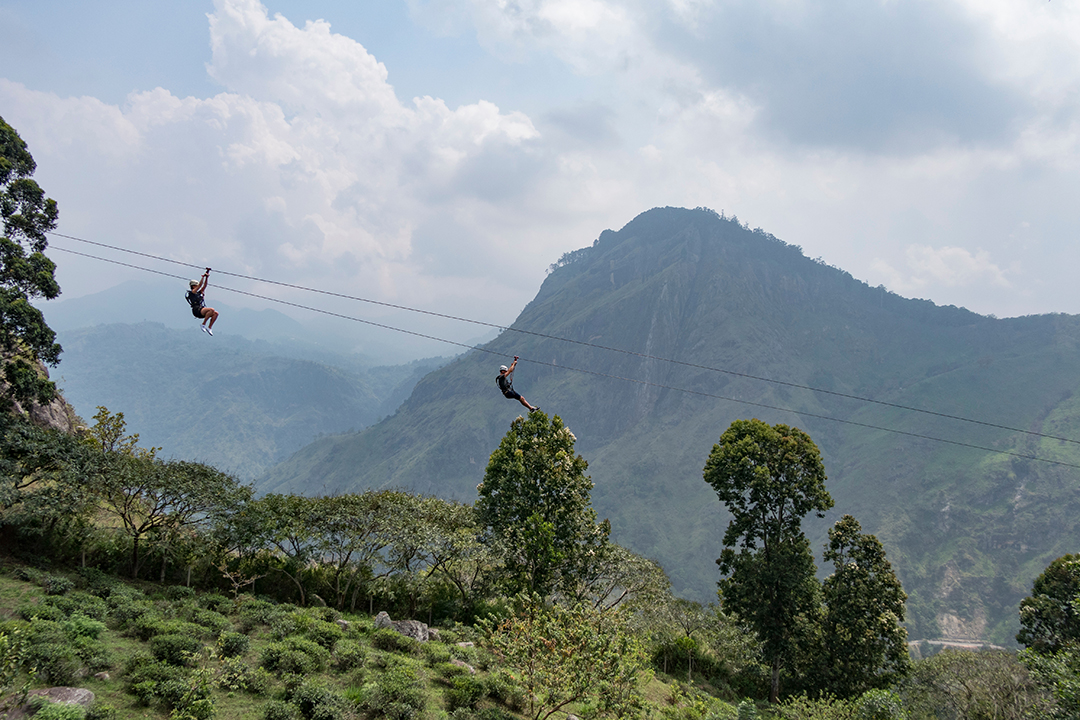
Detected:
left=482, top=596, right=646, bottom=720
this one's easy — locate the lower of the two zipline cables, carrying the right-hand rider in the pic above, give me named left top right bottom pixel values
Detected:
left=53, top=245, right=1080, bottom=470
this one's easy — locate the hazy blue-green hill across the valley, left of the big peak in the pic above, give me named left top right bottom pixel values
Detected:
left=46, top=315, right=445, bottom=479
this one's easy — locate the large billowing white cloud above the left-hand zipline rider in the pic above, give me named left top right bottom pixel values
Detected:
left=0, top=0, right=538, bottom=319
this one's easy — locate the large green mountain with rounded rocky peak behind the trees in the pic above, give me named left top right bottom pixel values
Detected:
left=258, top=208, right=1080, bottom=643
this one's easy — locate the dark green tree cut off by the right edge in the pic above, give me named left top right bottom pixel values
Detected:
left=1016, top=554, right=1080, bottom=653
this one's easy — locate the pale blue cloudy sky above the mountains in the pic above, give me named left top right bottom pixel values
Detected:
left=0, top=0, right=1080, bottom=356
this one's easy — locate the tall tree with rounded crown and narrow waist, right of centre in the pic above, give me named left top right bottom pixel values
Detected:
left=703, top=420, right=833, bottom=703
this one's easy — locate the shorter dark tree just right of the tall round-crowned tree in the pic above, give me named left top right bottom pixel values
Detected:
left=822, top=515, right=910, bottom=697
